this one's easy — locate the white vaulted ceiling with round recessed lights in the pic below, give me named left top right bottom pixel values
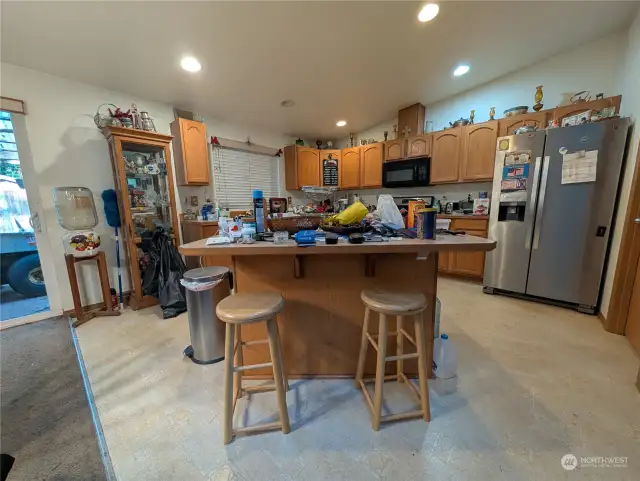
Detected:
left=1, top=1, right=638, bottom=138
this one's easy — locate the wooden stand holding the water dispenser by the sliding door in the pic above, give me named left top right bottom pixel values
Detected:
left=64, top=252, right=120, bottom=327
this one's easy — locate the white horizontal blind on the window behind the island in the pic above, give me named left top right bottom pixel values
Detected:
left=211, top=147, right=280, bottom=209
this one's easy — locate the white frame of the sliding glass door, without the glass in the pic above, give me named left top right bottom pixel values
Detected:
left=0, top=109, right=62, bottom=330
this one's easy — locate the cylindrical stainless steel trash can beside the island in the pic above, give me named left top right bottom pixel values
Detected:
left=183, top=267, right=230, bottom=364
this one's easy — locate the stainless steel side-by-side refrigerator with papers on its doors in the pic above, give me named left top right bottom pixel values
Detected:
left=484, top=118, right=629, bottom=314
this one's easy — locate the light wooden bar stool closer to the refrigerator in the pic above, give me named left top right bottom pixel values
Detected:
left=355, top=289, right=431, bottom=431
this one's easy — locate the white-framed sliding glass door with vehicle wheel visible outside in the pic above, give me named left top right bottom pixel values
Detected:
left=0, top=111, right=62, bottom=329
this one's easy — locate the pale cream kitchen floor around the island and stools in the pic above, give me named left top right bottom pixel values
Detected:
left=77, top=279, right=640, bottom=481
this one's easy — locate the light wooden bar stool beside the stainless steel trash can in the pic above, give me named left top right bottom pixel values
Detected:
left=216, top=293, right=291, bottom=444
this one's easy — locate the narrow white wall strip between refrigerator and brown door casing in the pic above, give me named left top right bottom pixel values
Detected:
left=600, top=9, right=640, bottom=317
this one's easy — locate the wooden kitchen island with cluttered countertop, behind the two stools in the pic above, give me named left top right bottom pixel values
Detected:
left=179, top=235, right=496, bottom=378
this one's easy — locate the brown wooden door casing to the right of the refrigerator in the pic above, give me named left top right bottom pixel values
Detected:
left=603, top=142, right=640, bottom=336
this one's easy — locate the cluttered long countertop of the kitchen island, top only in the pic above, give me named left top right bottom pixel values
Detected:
left=178, top=235, right=496, bottom=256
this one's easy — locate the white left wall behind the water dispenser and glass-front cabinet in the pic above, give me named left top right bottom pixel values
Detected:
left=0, top=63, right=293, bottom=309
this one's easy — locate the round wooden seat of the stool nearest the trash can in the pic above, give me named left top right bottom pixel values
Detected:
left=216, top=292, right=284, bottom=324
